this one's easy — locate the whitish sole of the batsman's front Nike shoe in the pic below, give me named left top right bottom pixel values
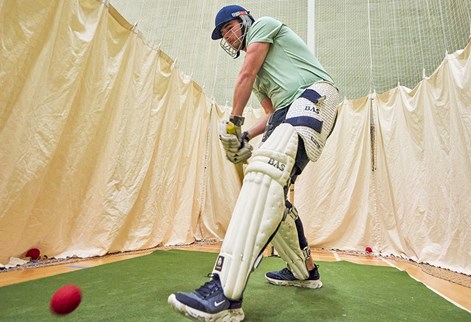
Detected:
left=168, top=294, right=245, bottom=322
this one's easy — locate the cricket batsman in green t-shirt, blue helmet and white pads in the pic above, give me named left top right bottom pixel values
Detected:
left=168, top=5, right=340, bottom=321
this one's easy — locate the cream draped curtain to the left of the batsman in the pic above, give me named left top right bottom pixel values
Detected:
left=0, top=0, right=240, bottom=263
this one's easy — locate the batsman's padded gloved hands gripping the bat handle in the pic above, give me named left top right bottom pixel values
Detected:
left=219, top=121, right=253, bottom=164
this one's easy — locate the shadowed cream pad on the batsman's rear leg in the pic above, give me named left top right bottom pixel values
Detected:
left=271, top=208, right=309, bottom=280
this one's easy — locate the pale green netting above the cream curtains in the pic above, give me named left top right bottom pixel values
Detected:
left=110, top=0, right=471, bottom=103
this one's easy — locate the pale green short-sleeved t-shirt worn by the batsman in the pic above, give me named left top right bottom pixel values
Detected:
left=246, top=17, right=333, bottom=110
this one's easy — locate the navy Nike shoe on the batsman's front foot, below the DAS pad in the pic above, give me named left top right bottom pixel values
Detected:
left=168, top=274, right=244, bottom=322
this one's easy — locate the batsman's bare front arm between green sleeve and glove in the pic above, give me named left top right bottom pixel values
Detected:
left=231, top=42, right=270, bottom=116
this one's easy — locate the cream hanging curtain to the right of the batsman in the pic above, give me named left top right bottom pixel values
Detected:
left=295, top=44, right=471, bottom=274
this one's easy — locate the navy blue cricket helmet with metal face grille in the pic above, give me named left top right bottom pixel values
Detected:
left=211, top=5, right=255, bottom=58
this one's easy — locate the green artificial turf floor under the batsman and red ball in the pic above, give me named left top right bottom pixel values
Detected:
left=0, top=250, right=471, bottom=322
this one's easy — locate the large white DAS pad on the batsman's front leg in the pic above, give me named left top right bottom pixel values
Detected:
left=213, top=124, right=298, bottom=300
